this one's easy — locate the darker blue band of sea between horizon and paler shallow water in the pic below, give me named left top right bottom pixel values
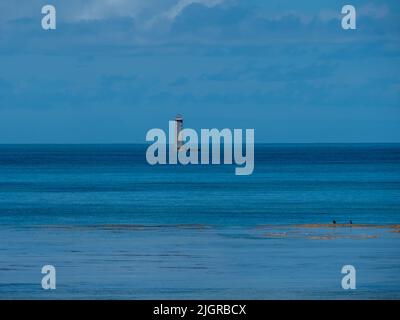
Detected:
left=0, top=144, right=400, bottom=226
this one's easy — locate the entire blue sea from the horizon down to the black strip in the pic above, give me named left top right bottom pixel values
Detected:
left=0, top=144, right=400, bottom=299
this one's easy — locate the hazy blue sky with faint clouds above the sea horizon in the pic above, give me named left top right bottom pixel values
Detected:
left=0, top=0, right=400, bottom=143
